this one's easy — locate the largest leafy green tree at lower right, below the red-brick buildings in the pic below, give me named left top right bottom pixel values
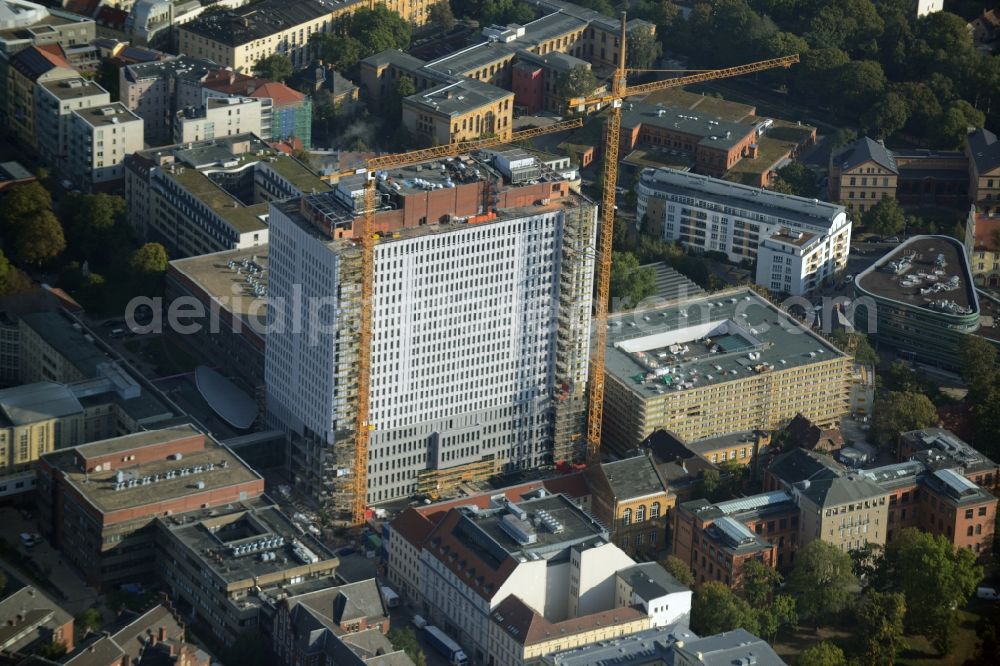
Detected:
left=877, top=528, right=983, bottom=655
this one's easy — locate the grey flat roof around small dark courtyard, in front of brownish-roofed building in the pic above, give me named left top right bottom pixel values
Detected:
left=161, top=497, right=337, bottom=584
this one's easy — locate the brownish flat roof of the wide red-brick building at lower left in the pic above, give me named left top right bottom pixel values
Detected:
left=45, top=425, right=261, bottom=513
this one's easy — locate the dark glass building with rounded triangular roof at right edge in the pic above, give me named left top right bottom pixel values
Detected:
left=854, top=236, right=980, bottom=371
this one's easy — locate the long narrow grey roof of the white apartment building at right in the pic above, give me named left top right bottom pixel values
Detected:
left=641, top=168, right=845, bottom=232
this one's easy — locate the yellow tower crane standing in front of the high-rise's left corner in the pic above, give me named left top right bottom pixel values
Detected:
left=331, top=118, right=583, bottom=525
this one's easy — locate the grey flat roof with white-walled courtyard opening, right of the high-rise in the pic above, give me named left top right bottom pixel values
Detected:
left=605, top=288, right=847, bottom=399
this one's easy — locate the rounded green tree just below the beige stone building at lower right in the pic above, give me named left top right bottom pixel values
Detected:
left=785, top=539, right=857, bottom=626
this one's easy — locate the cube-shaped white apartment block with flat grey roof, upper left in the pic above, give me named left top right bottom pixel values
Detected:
left=65, top=102, right=143, bottom=192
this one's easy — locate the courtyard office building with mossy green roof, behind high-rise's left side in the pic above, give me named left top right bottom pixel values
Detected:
left=125, top=134, right=330, bottom=257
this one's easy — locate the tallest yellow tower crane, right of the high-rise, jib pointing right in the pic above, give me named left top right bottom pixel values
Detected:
left=569, top=12, right=799, bottom=462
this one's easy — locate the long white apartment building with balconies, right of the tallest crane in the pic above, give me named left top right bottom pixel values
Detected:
left=636, top=169, right=851, bottom=295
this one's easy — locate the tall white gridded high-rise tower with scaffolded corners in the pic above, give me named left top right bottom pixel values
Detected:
left=265, top=195, right=596, bottom=503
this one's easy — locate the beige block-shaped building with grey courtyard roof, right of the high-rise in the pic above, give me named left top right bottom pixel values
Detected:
left=604, top=289, right=852, bottom=451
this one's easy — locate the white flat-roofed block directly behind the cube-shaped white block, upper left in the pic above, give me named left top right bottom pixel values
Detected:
left=35, top=76, right=111, bottom=175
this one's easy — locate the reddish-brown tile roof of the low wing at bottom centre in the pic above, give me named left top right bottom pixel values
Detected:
left=492, top=594, right=646, bottom=646
